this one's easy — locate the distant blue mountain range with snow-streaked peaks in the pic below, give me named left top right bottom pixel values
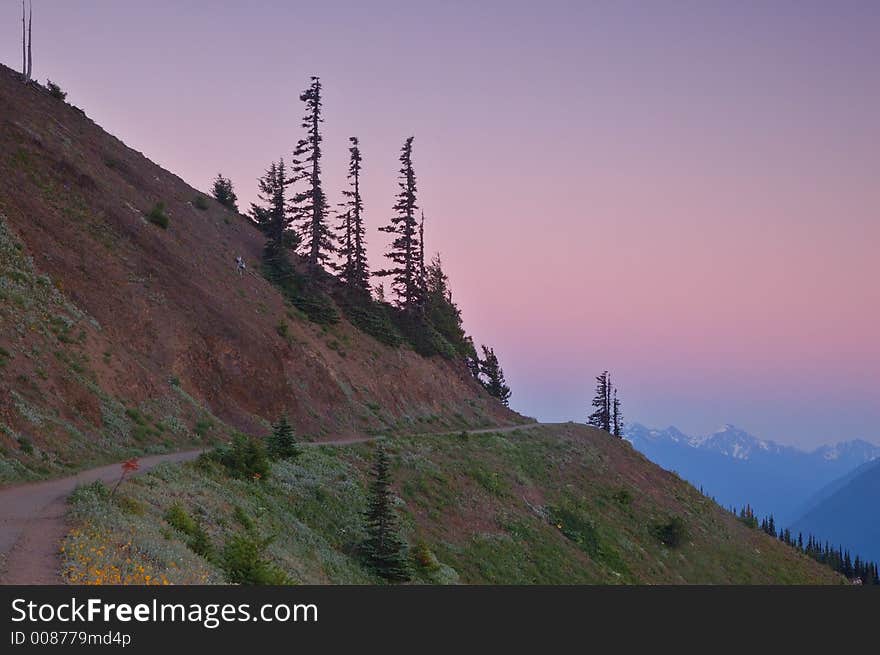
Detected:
left=626, top=423, right=880, bottom=525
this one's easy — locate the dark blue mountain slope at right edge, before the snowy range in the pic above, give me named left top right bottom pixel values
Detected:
left=793, top=461, right=880, bottom=561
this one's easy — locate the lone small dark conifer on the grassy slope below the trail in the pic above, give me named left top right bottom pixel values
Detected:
left=363, top=446, right=409, bottom=581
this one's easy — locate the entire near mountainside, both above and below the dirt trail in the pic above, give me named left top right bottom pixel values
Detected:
left=0, top=68, right=840, bottom=583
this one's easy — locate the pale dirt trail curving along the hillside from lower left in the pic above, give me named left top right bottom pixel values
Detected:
left=0, top=423, right=540, bottom=585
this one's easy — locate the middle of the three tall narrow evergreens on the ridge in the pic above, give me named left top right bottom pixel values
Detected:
left=337, top=136, right=370, bottom=296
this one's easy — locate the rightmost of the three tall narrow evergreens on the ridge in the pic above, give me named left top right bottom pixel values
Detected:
left=376, top=137, right=421, bottom=312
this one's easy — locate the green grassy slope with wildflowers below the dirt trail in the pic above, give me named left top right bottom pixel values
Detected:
left=65, top=425, right=841, bottom=584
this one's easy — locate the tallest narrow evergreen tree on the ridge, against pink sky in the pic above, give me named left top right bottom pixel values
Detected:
left=293, top=77, right=335, bottom=278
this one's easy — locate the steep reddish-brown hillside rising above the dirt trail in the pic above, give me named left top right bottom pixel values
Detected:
left=0, top=67, right=522, bottom=483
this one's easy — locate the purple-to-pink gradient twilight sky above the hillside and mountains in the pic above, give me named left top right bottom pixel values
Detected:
left=0, top=0, right=880, bottom=447
